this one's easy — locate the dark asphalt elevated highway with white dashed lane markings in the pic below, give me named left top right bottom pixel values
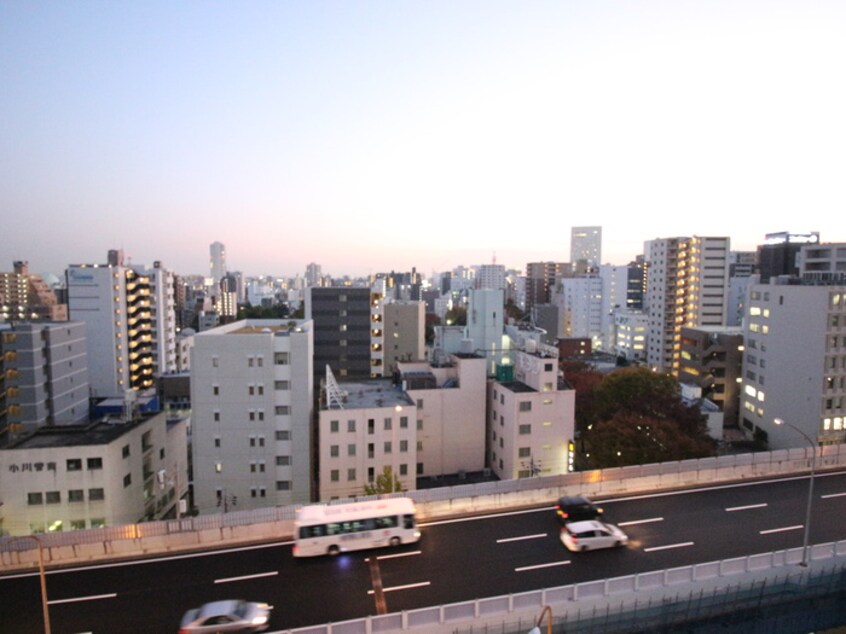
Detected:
left=0, top=474, right=846, bottom=634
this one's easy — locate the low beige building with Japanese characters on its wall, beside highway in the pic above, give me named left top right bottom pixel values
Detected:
left=0, top=414, right=188, bottom=535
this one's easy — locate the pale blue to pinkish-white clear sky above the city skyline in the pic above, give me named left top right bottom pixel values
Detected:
left=0, top=0, right=846, bottom=277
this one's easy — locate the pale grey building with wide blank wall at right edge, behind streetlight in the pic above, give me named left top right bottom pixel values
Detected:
left=740, top=280, right=846, bottom=449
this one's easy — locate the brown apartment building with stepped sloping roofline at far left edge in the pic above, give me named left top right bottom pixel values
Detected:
left=0, top=262, right=68, bottom=323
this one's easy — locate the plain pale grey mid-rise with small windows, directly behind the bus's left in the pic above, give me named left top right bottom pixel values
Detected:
left=191, top=319, right=314, bottom=513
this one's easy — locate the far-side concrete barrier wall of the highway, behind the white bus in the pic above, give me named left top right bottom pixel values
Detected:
left=0, top=445, right=846, bottom=573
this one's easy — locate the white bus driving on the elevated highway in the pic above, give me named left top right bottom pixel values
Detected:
left=294, top=498, right=420, bottom=557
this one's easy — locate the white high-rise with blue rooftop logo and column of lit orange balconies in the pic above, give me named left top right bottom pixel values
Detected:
left=66, top=251, right=176, bottom=398
